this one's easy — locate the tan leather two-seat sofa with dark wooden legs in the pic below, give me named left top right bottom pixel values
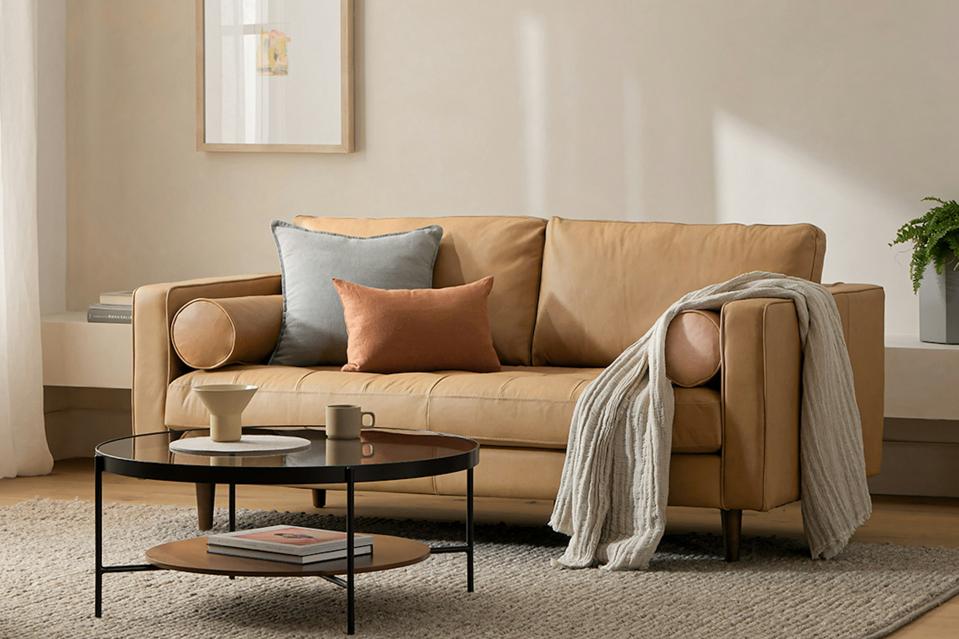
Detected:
left=133, top=216, right=884, bottom=559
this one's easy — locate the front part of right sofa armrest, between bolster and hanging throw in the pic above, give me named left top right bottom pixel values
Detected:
left=720, top=298, right=802, bottom=510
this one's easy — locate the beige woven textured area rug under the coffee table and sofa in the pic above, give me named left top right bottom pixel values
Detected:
left=0, top=500, right=959, bottom=639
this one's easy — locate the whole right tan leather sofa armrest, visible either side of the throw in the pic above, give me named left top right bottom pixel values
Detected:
left=720, top=284, right=885, bottom=510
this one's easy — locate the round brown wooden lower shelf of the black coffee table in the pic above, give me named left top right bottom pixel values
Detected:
left=146, top=535, right=430, bottom=577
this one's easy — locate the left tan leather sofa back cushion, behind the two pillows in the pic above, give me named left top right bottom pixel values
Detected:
left=294, top=215, right=546, bottom=365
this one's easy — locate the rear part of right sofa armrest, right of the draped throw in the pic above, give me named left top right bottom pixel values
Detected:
left=825, top=283, right=886, bottom=476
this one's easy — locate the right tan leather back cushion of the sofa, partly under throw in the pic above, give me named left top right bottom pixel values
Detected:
left=533, top=218, right=826, bottom=367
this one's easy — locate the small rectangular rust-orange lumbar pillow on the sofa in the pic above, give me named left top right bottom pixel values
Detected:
left=333, top=277, right=500, bottom=373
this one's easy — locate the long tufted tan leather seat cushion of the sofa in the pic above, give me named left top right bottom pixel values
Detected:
left=166, top=366, right=722, bottom=453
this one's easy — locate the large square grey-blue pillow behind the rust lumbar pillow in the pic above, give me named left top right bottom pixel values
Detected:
left=270, top=221, right=443, bottom=366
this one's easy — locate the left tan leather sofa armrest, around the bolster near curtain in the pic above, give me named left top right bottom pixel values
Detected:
left=133, top=274, right=282, bottom=458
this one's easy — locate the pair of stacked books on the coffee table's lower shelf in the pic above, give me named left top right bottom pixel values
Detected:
left=207, top=525, right=373, bottom=557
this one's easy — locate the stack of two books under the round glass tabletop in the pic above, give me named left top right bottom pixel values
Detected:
left=206, top=526, right=373, bottom=565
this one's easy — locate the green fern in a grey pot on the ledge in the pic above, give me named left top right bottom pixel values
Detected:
left=890, top=197, right=959, bottom=344
